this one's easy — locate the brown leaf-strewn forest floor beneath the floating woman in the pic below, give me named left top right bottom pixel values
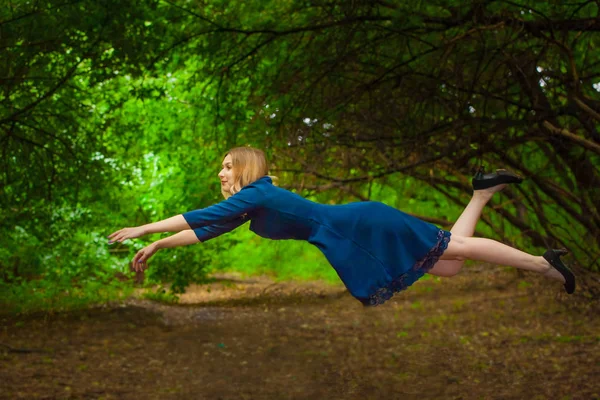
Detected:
left=0, top=267, right=600, bottom=400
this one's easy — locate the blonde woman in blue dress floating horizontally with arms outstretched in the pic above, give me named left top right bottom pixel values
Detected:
left=109, top=147, right=575, bottom=306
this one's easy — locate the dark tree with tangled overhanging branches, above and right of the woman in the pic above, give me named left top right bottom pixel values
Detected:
left=158, top=1, right=600, bottom=268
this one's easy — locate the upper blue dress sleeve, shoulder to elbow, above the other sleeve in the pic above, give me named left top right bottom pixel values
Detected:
left=182, top=185, right=263, bottom=229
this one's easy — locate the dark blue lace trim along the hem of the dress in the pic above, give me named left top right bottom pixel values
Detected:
left=359, top=229, right=451, bottom=307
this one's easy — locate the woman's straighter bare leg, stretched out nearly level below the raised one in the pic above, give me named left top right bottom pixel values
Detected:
left=441, top=235, right=565, bottom=283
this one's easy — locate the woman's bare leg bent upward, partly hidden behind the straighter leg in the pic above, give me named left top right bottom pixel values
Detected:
left=429, top=185, right=506, bottom=277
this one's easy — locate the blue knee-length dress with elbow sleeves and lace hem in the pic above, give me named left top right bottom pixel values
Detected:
left=183, top=176, right=450, bottom=306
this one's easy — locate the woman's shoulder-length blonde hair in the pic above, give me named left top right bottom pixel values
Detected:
left=221, top=147, right=278, bottom=198
